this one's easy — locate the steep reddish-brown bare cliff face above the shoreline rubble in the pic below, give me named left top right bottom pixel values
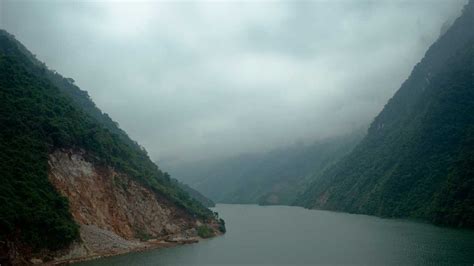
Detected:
left=49, top=150, right=196, bottom=239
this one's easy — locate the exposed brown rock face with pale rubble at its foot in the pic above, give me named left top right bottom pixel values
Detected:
left=49, top=150, right=209, bottom=259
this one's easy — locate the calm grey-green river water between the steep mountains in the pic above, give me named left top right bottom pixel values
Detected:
left=77, top=204, right=474, bottom=266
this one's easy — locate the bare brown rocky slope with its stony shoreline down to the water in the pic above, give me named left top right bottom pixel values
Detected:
left=2, top=149, right=223, bottom=265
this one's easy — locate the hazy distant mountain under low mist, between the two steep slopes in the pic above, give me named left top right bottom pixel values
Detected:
left=167, top=130, right=363, bottom=205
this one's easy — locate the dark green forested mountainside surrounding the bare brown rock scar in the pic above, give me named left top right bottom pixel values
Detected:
left=0, top=30, right=222, bottom=261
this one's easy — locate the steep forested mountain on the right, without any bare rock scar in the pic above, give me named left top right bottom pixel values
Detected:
left=297, top=1, right=474, bottom=227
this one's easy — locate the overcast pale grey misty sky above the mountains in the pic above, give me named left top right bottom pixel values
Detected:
left=0, top=0, right=466, bottom=162
